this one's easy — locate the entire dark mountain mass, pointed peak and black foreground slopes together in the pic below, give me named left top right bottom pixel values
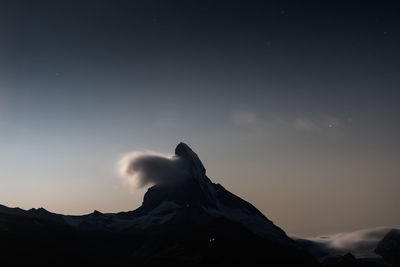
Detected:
left=0, top=146, right=391, bottom=266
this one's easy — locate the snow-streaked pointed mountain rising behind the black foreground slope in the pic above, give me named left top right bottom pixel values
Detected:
left=59, top=143, right=293, bottom=244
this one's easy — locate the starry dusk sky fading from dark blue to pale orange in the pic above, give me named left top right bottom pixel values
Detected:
left=0, top=0, right=400, bottom=235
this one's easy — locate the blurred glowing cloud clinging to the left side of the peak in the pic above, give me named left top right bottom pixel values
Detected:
left=119, top=151, right=189, bottom=188
